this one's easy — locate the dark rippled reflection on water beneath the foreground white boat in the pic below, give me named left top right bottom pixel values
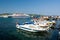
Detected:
left=16, top=29, right=52, bottom=40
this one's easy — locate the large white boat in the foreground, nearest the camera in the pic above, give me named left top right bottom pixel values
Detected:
left=16, top=22, right=52, bottom=32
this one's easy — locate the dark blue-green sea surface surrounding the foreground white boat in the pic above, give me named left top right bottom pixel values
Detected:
left=0, top=18, right=60, bottom=40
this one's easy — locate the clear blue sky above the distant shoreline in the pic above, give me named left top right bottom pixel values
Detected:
left=0, top=0, right=60, bottom=15
